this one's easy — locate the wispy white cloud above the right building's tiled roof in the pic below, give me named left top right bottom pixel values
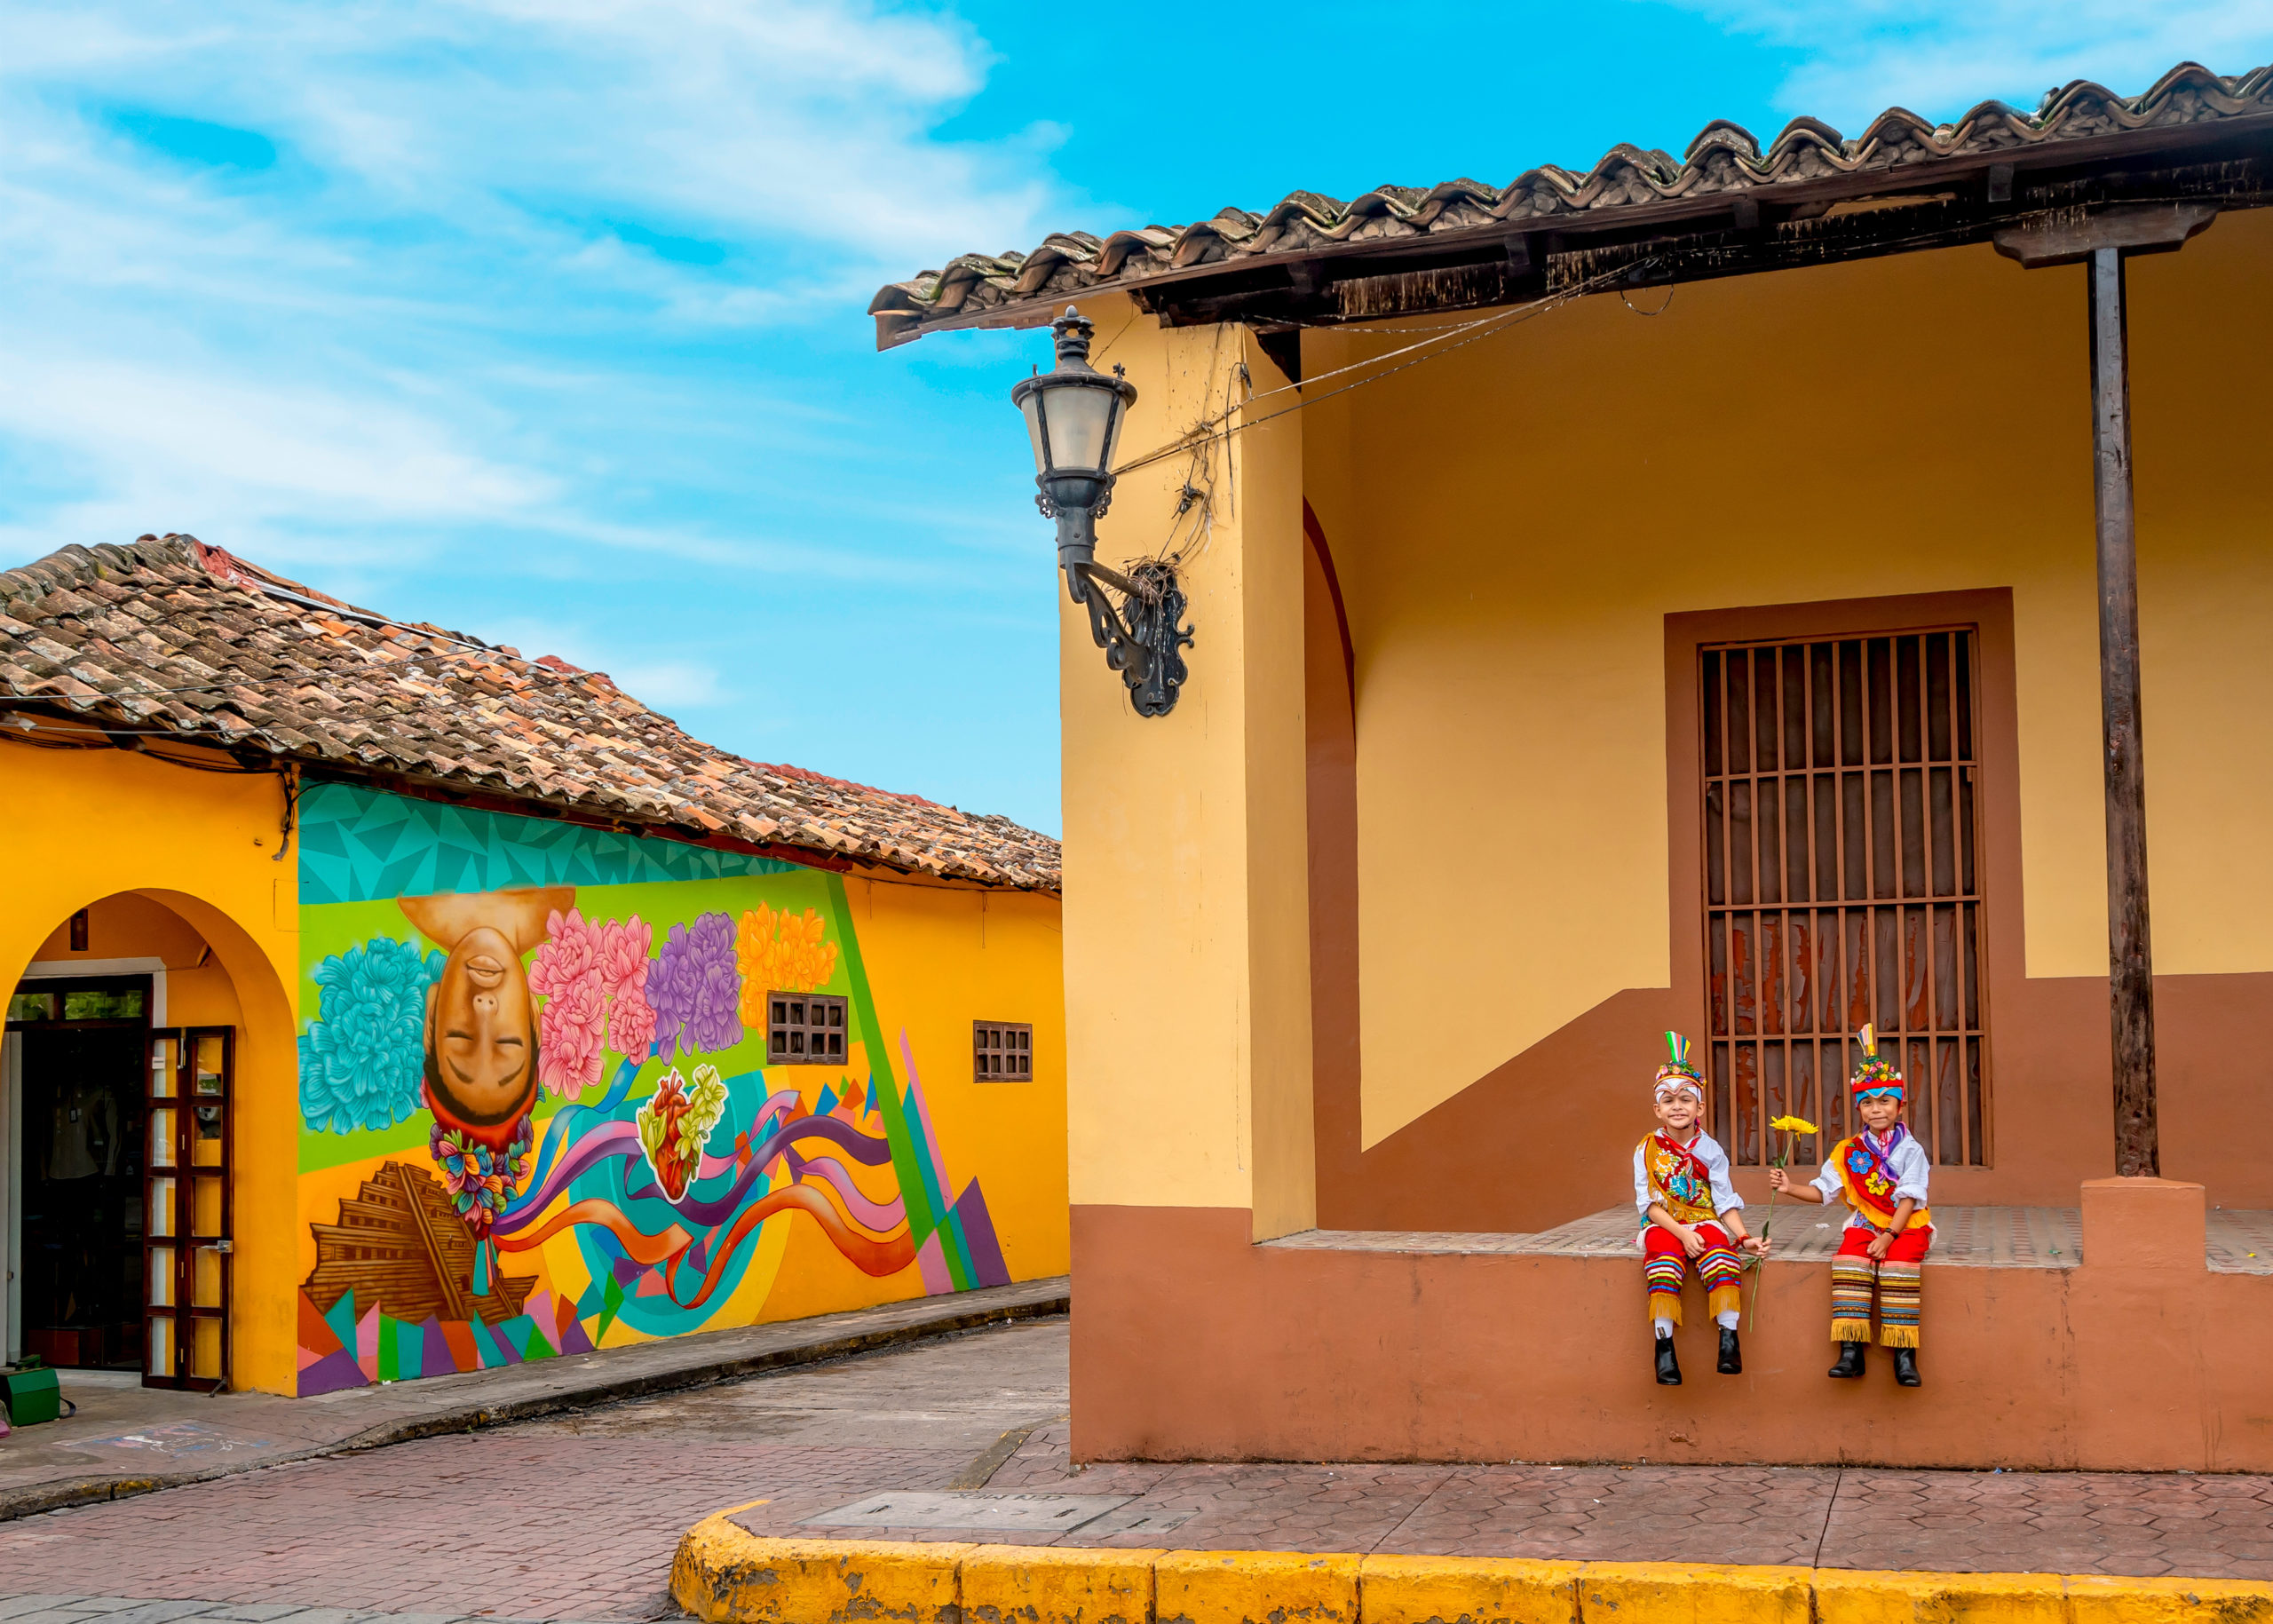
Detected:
left=1677, top=0, right=2273, bottom=134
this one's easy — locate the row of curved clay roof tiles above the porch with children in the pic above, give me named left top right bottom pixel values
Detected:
left=868, top=61, right=2273, bottom=348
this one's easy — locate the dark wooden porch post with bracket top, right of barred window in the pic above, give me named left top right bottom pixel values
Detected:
left=1996, top=202, right=2219, bottom=1178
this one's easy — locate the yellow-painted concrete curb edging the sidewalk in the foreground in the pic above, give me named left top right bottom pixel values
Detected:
left=670, top=1508, right=2273, bottom=1624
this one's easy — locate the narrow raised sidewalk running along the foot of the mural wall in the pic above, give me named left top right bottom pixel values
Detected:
left=0, top=1276, right=1066, bottom=1519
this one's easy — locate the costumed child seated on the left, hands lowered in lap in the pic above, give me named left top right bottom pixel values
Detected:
left=1635, top=1033, right=1769, bottom=1388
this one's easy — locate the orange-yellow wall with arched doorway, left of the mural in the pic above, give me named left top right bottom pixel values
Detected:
left=0, top=744, right=297, bottom=1392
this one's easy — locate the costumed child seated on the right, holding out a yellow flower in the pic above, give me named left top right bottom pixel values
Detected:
left=1769, top=1026, right=1935, bottom=1388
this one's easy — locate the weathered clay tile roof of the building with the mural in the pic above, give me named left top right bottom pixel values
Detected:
left=0, top=535, right=1059, bottom=891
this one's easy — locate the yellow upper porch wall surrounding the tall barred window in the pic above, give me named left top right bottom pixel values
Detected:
left=1300, top=214, right=2273, bottom=1144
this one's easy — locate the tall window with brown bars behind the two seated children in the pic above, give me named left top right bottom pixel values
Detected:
left=1698, top=628, right=1989, bottom=1167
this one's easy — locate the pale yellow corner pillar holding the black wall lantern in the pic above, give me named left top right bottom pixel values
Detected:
left=1058, top=309, right=1316, bottom=1235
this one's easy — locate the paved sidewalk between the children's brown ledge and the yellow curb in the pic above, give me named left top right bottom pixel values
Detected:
left=734, top=1424, right=2273, bottom=1579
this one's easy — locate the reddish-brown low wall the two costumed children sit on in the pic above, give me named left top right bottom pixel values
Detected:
left=1073, top=1180, right=2273, bottom=1471
